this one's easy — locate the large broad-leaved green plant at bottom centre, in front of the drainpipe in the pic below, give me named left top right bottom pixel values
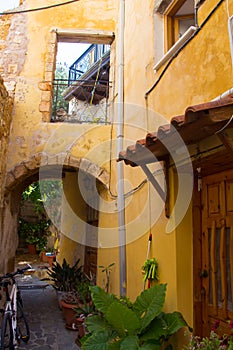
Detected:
left=82, top=284, right=188, bottom=350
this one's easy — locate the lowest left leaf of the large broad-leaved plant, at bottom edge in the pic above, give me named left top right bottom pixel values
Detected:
left=82, top=332, right=114, bottom=350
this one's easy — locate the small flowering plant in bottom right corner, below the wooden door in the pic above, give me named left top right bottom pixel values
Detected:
left=184, top=320, right=233, bottom=350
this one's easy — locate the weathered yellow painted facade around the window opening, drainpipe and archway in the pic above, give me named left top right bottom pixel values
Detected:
left=0, top=0, right=233, bottom=344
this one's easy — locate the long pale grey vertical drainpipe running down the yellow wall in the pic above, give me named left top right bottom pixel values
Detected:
left=117, top=0, right=126, bottom=295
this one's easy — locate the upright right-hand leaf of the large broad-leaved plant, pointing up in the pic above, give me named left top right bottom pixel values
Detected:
left=133, top=284, right=166, bottom=330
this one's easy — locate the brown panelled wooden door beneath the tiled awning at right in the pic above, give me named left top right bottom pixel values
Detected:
left=201, top=170, right=233, bottom=336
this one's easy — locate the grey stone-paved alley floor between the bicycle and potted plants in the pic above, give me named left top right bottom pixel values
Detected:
left=16, top=254, right=80, bottom=350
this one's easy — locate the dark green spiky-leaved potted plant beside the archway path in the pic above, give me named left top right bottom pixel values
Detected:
left=47, top=259, right=83, bottom=292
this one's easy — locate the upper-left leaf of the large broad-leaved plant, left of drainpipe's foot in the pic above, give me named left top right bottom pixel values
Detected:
left=90, top=286, right=118, bottom=314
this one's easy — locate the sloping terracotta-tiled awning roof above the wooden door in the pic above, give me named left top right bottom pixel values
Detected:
left=118, top=94, right=233, bottom=166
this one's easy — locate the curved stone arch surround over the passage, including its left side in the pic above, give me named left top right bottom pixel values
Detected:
left=0, top=153, right=109, bottom=272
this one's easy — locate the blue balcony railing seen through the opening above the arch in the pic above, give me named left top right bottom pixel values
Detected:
left=69, top=44, right=110, bottom=84
